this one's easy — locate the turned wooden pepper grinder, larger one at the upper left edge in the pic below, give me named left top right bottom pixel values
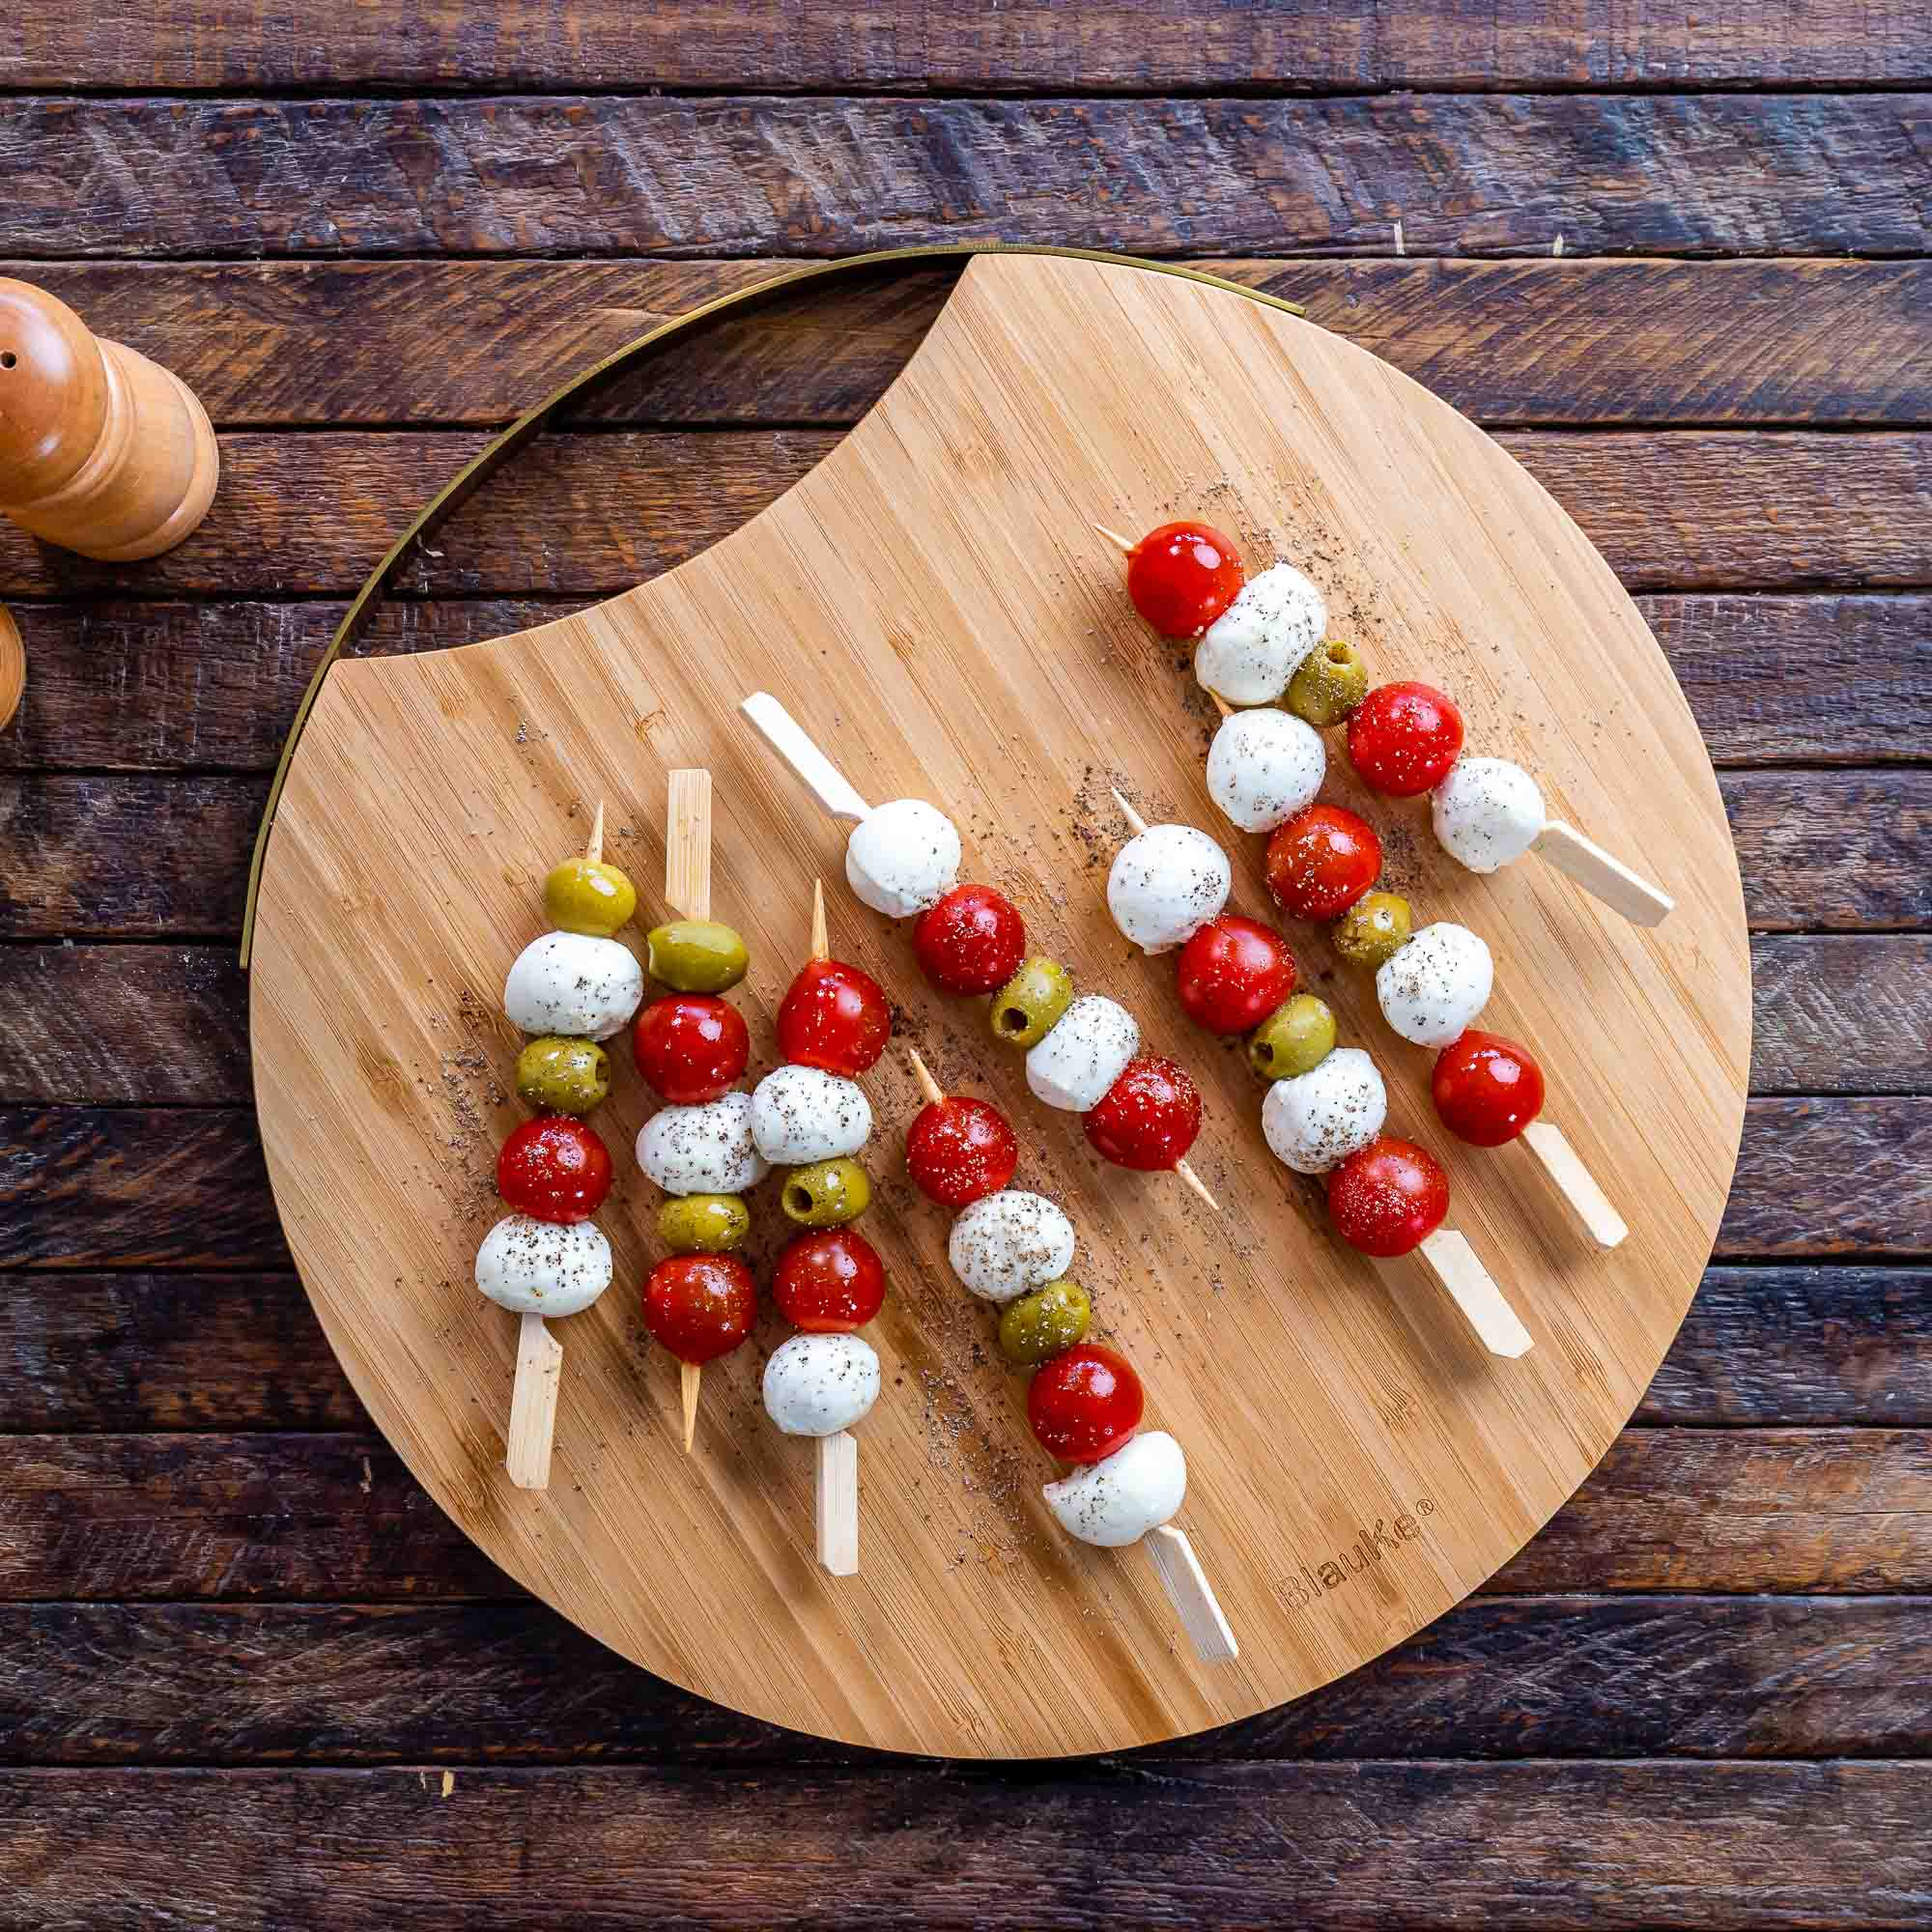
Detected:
left=0, top=278, right=220, bottom=564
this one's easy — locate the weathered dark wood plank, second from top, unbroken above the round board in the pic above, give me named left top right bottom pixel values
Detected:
left=14, top=93, right=1924, bottom=259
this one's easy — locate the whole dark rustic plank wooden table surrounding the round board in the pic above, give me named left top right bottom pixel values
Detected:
left=0, top=0, right=1932, bottom=1932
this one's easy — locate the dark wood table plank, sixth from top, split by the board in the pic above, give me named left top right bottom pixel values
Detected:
left=0, top=771, right=1932, bottom=939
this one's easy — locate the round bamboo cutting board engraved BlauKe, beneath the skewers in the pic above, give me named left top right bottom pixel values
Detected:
left=253, top=257, right=1750, bottom=1756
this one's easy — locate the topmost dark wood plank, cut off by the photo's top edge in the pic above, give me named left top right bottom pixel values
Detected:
left=6, top=0, right=1932, bottom=93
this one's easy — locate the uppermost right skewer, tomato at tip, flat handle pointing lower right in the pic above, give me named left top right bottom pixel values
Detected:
left=1094, top=522, right=1675, bottom=925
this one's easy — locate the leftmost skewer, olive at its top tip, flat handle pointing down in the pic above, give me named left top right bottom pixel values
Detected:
left=475, top=804, right=643, bottom=1490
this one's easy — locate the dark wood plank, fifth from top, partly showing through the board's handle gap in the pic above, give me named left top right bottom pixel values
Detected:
left=11, top=593, right=1932, bottom=777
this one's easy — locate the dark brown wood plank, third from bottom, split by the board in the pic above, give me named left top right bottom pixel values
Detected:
left=0, top=1428, right=1932, bottom=1602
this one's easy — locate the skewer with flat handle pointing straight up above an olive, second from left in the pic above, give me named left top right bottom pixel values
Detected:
left=632, top=769, right=767, bottom=1455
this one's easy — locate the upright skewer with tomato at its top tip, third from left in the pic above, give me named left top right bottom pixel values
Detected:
left=752, top=881, right=893, bottom=1577
